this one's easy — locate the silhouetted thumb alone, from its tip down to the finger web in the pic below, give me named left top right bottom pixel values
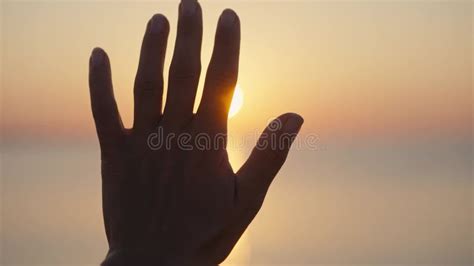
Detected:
left=237, top=113, right=304, bottom=204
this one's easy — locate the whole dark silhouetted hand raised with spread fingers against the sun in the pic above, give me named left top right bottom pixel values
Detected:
left=89, top=0, right=303, bottom=265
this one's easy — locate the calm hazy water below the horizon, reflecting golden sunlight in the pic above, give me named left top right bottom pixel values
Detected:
left=1, top=136, right=473, bottom=265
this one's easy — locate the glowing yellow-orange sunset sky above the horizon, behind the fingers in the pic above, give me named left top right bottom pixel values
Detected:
left=2, top=1, right=472, bottom=141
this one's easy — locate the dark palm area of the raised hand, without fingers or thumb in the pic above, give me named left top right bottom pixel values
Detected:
left=102, top=127, right=236, bottom=262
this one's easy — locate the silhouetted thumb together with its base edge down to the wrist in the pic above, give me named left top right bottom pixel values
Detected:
left=196, top=113, right=303, bottom=262
